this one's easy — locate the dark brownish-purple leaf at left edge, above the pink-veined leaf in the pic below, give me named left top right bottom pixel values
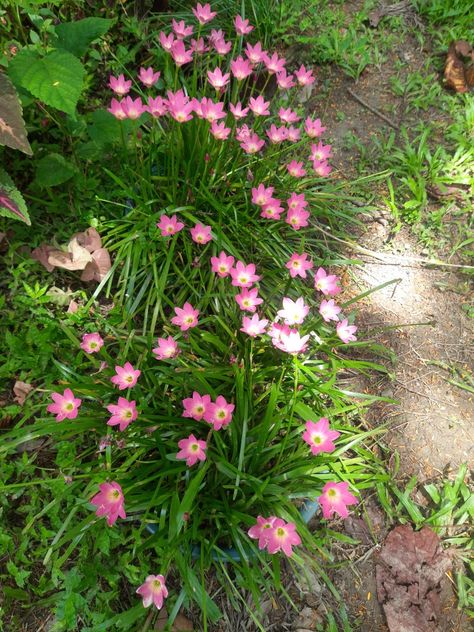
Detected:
left=0, top=73, right=33, bottom=156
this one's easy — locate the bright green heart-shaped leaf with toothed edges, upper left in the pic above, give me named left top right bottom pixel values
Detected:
left=8, top=49, right=85, bottom=116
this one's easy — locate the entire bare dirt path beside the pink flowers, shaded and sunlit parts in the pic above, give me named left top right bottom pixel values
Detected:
left=300, top=7, right=474, bottom=632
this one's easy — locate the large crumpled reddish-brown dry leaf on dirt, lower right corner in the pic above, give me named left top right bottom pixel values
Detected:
left=376, top=525, right=451, bottom=632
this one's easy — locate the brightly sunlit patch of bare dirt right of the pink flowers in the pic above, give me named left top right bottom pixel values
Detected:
left=354, top=224, right=474, bottom=479
